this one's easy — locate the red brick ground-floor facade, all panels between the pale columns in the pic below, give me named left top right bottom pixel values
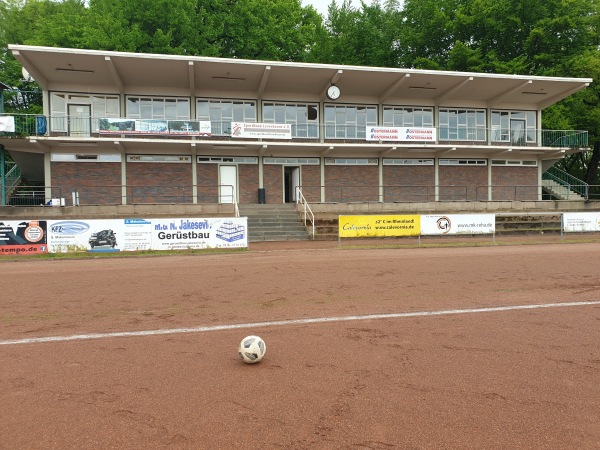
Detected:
left=51, top=158, right=538, bottom=205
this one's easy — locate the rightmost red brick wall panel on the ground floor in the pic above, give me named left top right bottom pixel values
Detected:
left=492, top=166, right=538, bottom=200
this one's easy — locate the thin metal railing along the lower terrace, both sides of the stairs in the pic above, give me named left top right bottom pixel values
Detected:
left=7, top=185, right=600, bottom=207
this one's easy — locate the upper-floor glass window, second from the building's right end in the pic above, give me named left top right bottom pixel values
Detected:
left=439, top=108, right=486, bottom=141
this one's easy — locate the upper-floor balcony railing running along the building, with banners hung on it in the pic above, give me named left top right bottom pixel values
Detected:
left=0, top=114, right=588, bottom=148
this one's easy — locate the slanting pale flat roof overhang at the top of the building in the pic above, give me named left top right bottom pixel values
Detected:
left=9, top=45, right=593, bottom=110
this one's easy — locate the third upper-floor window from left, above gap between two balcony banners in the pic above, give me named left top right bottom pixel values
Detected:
left=196, top=99, right=256, bottom=136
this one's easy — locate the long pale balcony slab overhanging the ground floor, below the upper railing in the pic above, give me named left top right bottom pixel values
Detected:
left=0, top=137, right=581, bottom=161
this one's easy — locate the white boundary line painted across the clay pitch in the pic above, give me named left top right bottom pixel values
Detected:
left=0, top=300, right=600, bottom=345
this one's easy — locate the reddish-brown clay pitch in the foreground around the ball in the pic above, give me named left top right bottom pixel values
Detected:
left=0, top=243, right=600, bottom=449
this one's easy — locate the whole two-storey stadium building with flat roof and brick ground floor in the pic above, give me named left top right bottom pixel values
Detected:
left=0, top=45, right=592, bottom=214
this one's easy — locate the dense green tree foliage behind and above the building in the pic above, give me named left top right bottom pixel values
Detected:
left=0, top=0, right=600, bottom=182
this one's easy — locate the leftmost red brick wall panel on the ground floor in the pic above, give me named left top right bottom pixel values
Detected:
left=50, top=162, right=122, bottom=205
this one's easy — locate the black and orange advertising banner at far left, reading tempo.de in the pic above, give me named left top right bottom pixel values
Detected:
left=0, top=220, right=48, bottom=256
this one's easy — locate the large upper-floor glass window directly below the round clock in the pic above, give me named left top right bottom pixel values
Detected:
left=325, top=105, right=377, bottom=139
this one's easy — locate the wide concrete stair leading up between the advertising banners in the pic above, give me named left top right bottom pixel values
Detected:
left=239, top=203, right=310, bottom=242
